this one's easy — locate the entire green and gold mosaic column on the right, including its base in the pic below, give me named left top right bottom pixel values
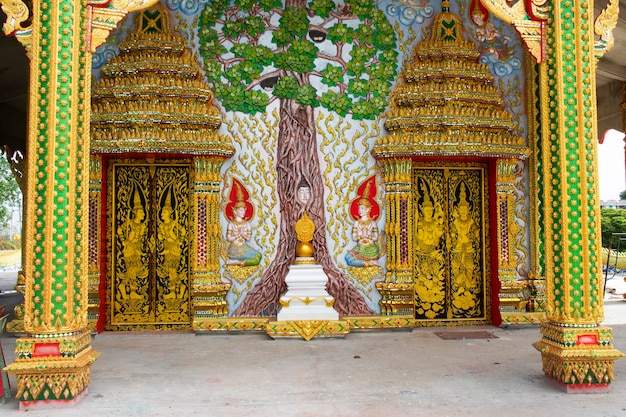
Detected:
left=534, top=0, right=623, bottom=392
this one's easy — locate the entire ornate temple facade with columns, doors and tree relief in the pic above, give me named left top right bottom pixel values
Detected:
left=0, top=0, right=622, bottom=404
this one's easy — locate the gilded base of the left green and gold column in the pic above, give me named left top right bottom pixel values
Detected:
left=4, top=330, right=99, bottom=409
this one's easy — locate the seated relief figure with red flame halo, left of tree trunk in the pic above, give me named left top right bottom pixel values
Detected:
left=226, top=178, right=261, bottom=266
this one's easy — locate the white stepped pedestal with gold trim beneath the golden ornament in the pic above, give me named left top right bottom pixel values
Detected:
left=276, top=264, right=339, bottom=322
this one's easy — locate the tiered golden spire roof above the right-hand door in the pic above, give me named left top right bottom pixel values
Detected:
left=373, top=1, right=529, bottom=158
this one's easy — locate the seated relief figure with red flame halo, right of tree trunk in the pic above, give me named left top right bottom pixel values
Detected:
left=345, top=176, right=380, bottom=267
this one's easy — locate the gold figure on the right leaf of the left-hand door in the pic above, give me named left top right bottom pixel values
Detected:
left=157, top=191, right=187, bottom=298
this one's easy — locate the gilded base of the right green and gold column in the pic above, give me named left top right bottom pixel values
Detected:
left=533, top=322, right=624, bottom=393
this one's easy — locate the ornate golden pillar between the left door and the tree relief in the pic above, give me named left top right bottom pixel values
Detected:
left=192, top=157, right=231, bottom=330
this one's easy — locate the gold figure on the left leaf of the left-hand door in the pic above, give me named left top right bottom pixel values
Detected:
left=117, top=190, right=148, bottom=299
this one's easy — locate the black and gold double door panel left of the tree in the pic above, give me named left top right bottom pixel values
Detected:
left=107, top=162, right=191, bottom=330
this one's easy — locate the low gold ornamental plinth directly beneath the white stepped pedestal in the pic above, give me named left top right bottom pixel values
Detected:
left=266, top=320, right=350, bottom=341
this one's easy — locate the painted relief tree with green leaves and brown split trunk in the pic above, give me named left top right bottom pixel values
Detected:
left=198, top=0, right=397, bottom=316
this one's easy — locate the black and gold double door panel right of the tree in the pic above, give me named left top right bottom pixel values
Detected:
left=413, top=165, right=490, bottom=324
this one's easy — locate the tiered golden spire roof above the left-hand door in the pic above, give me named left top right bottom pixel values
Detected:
left=91, top=5, right=234, bottom=157
